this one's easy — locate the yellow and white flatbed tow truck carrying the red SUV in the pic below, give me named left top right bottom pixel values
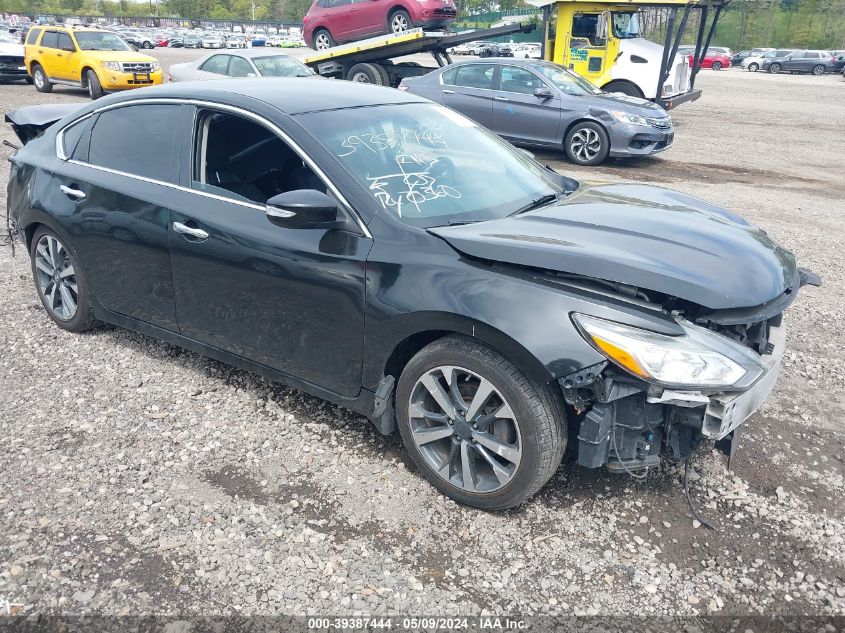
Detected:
left=303, top=0, right=730, bottom=110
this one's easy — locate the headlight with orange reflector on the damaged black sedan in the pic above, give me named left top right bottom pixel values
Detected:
left=572, top=314, right=765, bottom=389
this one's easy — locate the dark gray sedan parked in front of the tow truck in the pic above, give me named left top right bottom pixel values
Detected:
left=399, top=59, right=674, bottom=165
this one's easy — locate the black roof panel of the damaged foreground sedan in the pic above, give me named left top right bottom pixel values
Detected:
left=98, top=77, right=429, bottom=115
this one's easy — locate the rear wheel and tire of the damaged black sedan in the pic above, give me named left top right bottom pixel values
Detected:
left=29, top=226, right=96, bottom=332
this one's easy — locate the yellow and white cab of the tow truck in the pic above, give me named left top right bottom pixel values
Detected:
left=527, top=0, right=725, bottom=108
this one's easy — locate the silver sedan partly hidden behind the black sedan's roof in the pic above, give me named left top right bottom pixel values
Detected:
left=170, top=48, right=317, bottom=81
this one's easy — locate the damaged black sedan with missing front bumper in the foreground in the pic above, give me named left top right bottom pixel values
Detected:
left=7, top=79, right=818, bottom=508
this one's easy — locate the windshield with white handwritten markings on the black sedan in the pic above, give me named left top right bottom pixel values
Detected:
left=298, top=103, right=561, bottom=228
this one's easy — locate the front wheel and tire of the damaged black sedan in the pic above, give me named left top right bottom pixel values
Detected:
left=396, top=335, right=566, bottom=510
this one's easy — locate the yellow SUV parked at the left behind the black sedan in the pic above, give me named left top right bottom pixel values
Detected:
left=24, top=26, right=161, bottom=99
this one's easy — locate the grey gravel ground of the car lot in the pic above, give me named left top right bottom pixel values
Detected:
left=0, top=50, right=845, bottom=615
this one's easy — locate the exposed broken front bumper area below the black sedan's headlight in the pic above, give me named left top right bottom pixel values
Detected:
left=559, top=320, right=786, bottom=472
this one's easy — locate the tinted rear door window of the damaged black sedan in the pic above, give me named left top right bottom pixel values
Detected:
left=88, top=104, right=182, bottom=184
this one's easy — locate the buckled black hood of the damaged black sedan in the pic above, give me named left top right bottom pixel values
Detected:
left=429, top=184, right=797, bottom=310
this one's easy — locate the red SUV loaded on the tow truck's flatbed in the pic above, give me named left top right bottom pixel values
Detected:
left=303, top=0, right=458, bottom=51
